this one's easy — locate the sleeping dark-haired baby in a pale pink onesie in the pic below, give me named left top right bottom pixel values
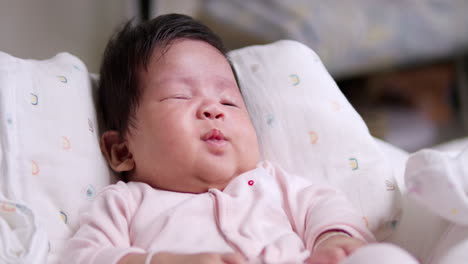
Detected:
left=66, top=14, right=418, bottom=264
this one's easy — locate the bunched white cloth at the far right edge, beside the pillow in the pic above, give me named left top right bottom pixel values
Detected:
left=405, top=148, right=468, bottom=264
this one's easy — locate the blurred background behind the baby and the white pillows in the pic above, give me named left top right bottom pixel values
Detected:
left=0, top=0, right=468, bottom=152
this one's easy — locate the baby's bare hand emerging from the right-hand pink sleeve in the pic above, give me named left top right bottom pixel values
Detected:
left=306, top=232, right=366, bottom=264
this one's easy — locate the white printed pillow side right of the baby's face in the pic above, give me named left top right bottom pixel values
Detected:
left=229, top=40, right=401, bottom=240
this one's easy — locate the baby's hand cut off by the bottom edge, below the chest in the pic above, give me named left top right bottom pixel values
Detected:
left=150, top=253, right=247, bottom=264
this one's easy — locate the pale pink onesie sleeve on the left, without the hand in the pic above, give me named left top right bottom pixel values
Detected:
left=62, top=182, right=145, bottom=264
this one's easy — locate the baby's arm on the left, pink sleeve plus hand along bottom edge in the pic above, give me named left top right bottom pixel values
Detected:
left=66, top=183, right=249, bottom=264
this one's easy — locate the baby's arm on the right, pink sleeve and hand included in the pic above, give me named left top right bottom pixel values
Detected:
left=266, top=164, right=375, bottom=263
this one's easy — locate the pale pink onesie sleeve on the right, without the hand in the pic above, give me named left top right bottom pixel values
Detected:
left=262, top=162, right=375, bottom=251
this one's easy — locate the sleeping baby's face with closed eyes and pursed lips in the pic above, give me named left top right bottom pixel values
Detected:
left=126, top=39, right=259, bottom=193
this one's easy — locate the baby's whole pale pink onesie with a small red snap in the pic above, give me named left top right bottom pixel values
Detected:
left=64, top=162, right=374, bottom=263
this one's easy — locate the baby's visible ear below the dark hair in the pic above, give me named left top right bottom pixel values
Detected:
left=101, top=130, right=135, bottom=172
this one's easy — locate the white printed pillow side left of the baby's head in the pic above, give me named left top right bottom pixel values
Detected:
left=0, top=52, right=113, bottom=262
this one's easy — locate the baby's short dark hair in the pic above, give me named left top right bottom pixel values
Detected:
left=98, top=14, right=227, bottom=136
